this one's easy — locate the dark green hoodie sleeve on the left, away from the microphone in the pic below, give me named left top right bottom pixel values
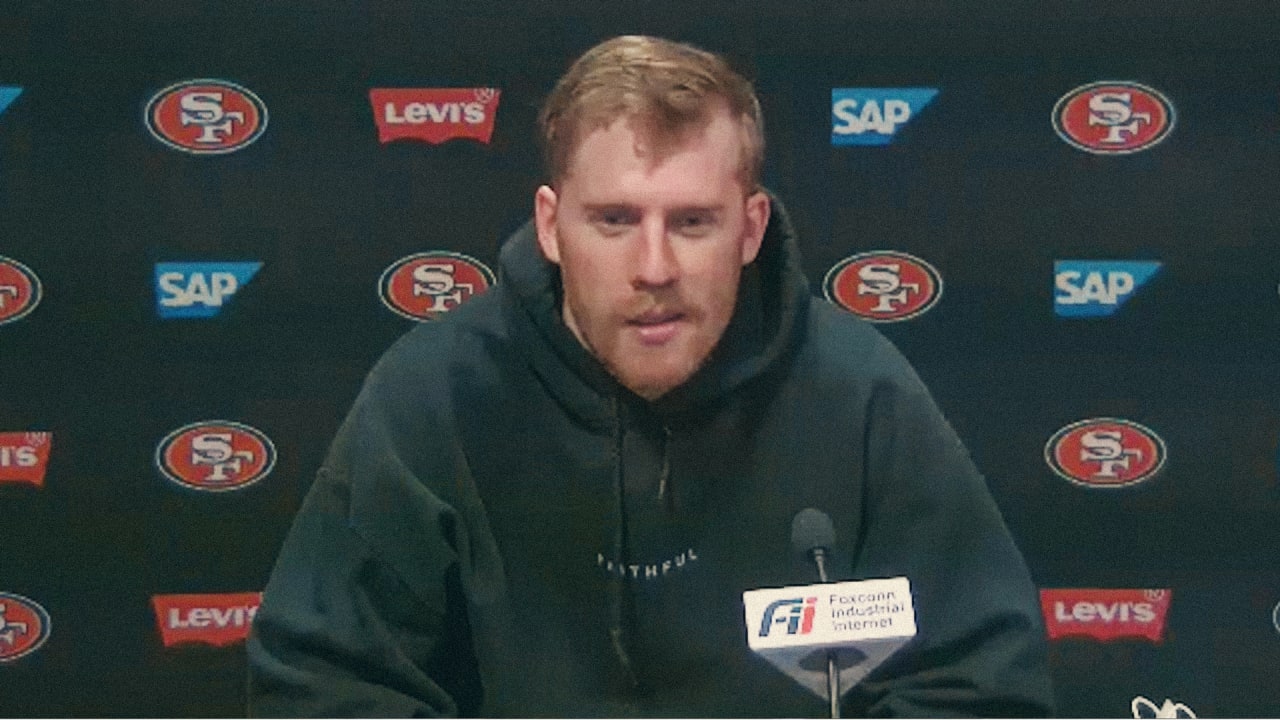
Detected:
left=247, top=356, right=480, bottom=717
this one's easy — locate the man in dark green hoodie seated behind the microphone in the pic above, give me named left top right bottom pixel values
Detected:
left=248, top=37, right=1051, bottom=716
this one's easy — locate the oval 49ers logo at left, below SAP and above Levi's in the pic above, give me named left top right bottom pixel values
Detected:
left=156, top=420, right=275, bottom=492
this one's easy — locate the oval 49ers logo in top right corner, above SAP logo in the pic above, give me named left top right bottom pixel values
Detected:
left=1053, top=81, right=1174, bottom=155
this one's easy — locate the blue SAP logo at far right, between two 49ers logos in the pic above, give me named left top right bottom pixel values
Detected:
left=1053, top=260, right=1161, bottom=318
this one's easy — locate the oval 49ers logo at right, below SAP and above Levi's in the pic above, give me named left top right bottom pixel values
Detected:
left=1044, top=418, right=1166, bottom=488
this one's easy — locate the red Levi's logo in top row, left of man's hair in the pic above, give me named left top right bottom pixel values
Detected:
left=369, top=87, right=502, bottom=145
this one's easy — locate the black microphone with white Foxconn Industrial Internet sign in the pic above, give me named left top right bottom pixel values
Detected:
left=742, top=507, right=915, bottom=717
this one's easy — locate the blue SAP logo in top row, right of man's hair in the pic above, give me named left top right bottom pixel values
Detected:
left=831, top=87, right=938, bottom=145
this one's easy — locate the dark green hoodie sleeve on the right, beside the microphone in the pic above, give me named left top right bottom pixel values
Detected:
left=846, top=360, right=1053, bottom=717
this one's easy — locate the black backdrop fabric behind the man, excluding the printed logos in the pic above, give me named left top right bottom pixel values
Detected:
left=0, top=0, right=1280, bottom=716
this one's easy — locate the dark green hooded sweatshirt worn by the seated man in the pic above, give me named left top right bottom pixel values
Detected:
left=248, top=194, right=1052, bottom=717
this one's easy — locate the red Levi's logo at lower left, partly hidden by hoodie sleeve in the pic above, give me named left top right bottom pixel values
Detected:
left=151, top=592, right=262, bottom=647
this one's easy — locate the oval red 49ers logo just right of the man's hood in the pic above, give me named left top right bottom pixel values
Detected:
left=822, top=250, right=942, bottom=323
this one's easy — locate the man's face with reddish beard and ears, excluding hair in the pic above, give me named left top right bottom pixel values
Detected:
left=535, top=110, right=769, bottom=400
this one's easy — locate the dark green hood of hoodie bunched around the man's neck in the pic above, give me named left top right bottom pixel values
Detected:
left=498, top=193, right=810, bottom=425
